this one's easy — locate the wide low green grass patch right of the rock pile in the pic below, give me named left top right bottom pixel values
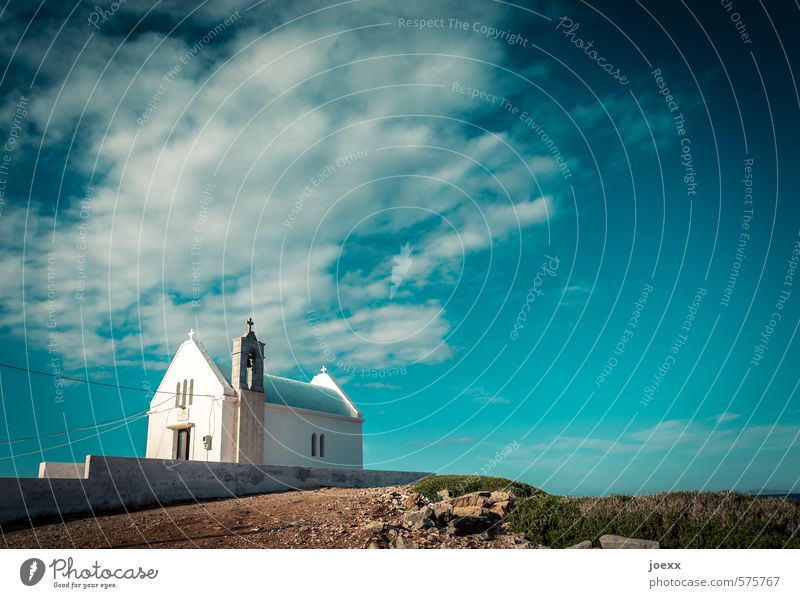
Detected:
left=507, top=492, right=800, bottom=548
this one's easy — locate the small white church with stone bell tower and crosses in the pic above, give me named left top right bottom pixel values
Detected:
left=147, top=318, right=364, bottom=469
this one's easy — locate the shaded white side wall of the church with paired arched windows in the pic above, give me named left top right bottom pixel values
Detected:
left=264, top=404, right=363, bottom=469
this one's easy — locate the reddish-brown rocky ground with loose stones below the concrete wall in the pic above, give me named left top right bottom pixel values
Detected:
left=2, top=486, right=552, bottom=548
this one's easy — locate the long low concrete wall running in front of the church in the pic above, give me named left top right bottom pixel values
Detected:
left=0, top=456, right=430, bottom=523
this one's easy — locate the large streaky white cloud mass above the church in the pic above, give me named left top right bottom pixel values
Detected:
left=0, top=2, right=568, bottom=378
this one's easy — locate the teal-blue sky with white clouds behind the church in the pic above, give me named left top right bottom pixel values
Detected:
left=0, top=0, right=800, bottom=494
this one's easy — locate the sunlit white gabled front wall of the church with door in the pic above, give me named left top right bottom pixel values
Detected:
left=146, top=340, right=234, bottom=461
